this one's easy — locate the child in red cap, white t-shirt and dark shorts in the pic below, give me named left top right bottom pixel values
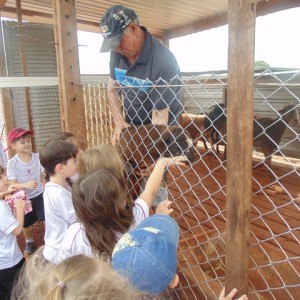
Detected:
left=7, top=128, right=45, bottom=255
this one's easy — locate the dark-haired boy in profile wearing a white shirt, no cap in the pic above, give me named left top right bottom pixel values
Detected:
left=40, top=140, right=77, bottom=263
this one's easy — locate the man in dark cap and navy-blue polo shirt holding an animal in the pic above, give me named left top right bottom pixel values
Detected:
left=100, top=5, right=183, bottom=145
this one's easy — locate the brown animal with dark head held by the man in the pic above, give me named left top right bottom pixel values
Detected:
left=116, top=124, right=195, bottom=197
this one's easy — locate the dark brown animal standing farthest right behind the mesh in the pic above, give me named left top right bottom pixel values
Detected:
left=253, top=104, right=300, bottom=169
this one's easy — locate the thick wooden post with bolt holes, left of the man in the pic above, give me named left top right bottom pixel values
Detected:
left=52, top=0, right=86, bottom=147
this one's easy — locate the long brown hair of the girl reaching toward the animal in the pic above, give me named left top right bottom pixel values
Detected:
left=72, top=168, right=134, bottom=256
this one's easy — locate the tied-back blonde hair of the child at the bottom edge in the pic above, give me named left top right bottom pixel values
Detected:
left=11, top=248, right=142, bottom=300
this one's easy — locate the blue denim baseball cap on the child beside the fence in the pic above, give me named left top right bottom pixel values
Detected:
left=112, top=214, right=179, bottom=295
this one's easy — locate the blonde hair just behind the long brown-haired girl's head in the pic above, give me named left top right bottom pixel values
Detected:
left=78, top=144, right=124, bottom=177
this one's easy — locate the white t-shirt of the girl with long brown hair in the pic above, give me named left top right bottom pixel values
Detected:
left=58, top=198, right=149, bottom=262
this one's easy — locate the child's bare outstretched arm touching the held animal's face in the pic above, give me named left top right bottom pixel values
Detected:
left=140, top=156, right=188, bottom=208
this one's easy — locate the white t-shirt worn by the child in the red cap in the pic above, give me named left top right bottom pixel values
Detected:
left=7, top=152, right=44, bottom=198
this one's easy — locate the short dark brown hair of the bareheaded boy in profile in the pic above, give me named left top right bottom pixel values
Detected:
left=39, top=140, right=77, bottom=177
